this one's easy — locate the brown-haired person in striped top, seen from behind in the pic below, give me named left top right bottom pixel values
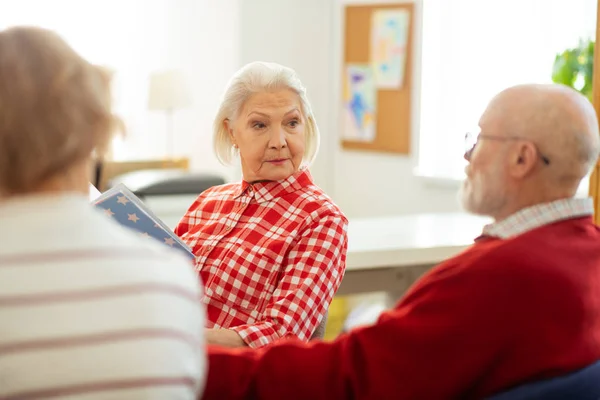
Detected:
left=0, top=27, right=205, bottom=400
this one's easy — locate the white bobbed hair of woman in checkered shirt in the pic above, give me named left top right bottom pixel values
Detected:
left=213, top=62, right=320, bottom=165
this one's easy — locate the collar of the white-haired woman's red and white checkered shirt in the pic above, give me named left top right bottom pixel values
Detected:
left=233, top=168, right=313, bottom=203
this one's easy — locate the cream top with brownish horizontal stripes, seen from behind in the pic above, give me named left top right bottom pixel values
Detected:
left=0, top=195, right=205, bottom=400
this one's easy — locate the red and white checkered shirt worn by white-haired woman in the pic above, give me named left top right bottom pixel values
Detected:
left=175, top=170, right=348, bottom=347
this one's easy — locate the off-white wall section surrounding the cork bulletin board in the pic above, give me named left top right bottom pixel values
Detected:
left=240, top=0, right=458, bottom=217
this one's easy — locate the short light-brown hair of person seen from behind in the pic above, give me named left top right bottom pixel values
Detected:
left=0, top=27, right=120, bottom=196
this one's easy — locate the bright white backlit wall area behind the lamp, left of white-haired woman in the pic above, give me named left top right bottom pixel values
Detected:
left=0, top=0, right=240, bottom=178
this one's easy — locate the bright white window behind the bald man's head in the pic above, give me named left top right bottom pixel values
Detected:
left=417, top=0, right=596, bottom=192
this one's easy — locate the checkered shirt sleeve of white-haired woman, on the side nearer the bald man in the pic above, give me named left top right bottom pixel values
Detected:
left=231, top=214, right=348, bottom=347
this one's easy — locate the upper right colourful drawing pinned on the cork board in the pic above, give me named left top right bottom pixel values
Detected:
left=371, top=9, right=410, bottom=89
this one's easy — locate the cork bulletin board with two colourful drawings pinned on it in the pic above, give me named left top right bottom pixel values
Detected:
left=341, top=3, right=414, bottom=154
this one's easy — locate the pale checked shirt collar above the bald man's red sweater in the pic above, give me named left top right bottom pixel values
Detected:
left=483, top=198, right=594, bottom=239
